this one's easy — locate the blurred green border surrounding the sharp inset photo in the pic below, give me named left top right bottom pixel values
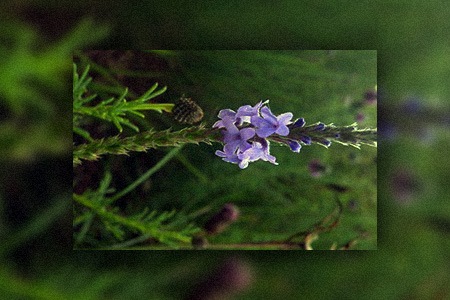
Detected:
left=0, top=0, right=450, bottom=299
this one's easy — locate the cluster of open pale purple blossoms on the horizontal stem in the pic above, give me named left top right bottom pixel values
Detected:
left=213, top=100, right=300, bottom=169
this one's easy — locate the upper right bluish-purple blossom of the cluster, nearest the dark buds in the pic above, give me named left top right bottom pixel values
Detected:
left=251, top=106, right=293, bottom=138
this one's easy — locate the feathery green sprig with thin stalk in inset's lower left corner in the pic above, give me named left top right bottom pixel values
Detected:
left=73, top=149, right=198, bottom=248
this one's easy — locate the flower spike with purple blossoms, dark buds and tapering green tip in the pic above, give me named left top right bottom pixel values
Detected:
left=213, top=100, right=377, bottom=169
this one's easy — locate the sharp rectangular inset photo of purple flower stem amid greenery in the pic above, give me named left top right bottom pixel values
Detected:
left=73, top=50, right=377, bottom=251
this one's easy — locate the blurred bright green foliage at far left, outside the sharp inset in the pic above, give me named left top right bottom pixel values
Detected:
left=0, top=18, right=109, bottom=161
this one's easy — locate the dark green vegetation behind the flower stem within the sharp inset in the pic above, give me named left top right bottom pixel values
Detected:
left=74, top=51, right=377, bottom=249
